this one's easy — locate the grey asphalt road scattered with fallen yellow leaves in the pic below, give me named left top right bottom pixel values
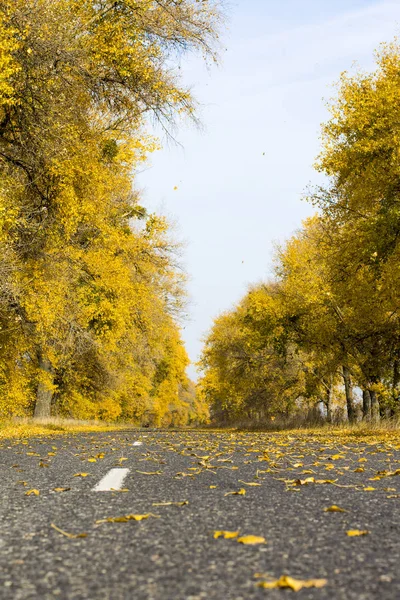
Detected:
left=0, top=430, right=400, bottom=600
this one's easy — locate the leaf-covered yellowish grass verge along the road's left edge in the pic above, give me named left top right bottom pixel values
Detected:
left=0, top=417, right=135, bottom=439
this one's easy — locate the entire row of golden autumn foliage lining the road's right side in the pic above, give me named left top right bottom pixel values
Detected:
left=199, top=43, right=400, bottom=423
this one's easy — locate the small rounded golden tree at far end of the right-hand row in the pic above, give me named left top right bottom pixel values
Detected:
left=199, top=283, right=305, bottom=423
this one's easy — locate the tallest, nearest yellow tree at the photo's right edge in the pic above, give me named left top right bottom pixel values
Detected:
left=313, top=44, right=400, bottom=420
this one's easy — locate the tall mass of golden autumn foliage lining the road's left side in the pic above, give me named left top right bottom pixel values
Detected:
left=0, top=0, right=220, bottom=425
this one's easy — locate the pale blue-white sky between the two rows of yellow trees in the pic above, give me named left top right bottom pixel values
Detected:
left=137, top=0, right=400, bottom=379
